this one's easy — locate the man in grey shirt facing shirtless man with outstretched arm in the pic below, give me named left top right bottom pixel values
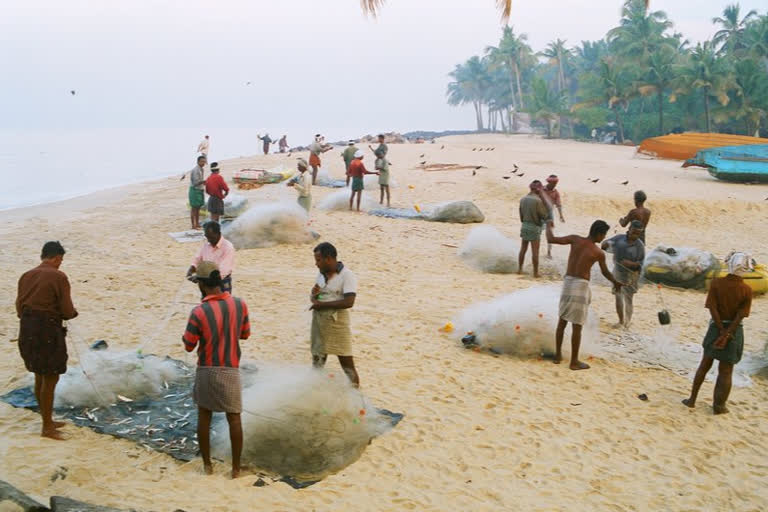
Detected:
left=601, top=220, right=645, bottom=328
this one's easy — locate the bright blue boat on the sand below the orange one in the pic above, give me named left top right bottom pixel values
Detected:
left=683, top=144, right=768, bottom=183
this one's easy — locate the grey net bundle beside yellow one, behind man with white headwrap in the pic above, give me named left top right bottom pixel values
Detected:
left=643, top=245, right=720, bottom=289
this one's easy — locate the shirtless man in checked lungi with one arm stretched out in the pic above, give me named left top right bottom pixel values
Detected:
left=547, top=220, right=621, bottom=370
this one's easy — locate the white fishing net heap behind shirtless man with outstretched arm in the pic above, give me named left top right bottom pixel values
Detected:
left=453, top=286, right=598, bottom=357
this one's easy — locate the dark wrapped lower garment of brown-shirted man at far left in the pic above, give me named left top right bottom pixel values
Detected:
left=19, top=311, right=67, bottom=375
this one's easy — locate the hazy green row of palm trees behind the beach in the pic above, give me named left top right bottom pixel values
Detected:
left=447, top=0, right=768, bottom=143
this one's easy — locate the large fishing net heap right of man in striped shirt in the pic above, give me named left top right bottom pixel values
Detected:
left=211, top=364, right=402, bottom=481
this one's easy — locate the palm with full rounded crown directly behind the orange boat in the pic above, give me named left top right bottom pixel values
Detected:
left=670, top=41, right=734, bottom=132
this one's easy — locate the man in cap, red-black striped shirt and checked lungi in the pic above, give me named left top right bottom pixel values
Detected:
left=182, top=261, right=251, bottom=478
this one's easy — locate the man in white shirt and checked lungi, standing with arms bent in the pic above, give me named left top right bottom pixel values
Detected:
left=310, top=242, right=360, bottom=387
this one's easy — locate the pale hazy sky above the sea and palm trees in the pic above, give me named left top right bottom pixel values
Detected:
left=0, top=0, right=765, bottom=144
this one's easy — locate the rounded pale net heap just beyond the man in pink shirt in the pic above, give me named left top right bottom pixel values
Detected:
left=224, top=201, right=315, bottom=249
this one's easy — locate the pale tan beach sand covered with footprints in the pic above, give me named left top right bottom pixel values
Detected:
left=0, top=136, right=768, bottom=511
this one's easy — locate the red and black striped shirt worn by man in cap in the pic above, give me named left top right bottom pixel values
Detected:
left=181, top=292, right=251, bottom=368
